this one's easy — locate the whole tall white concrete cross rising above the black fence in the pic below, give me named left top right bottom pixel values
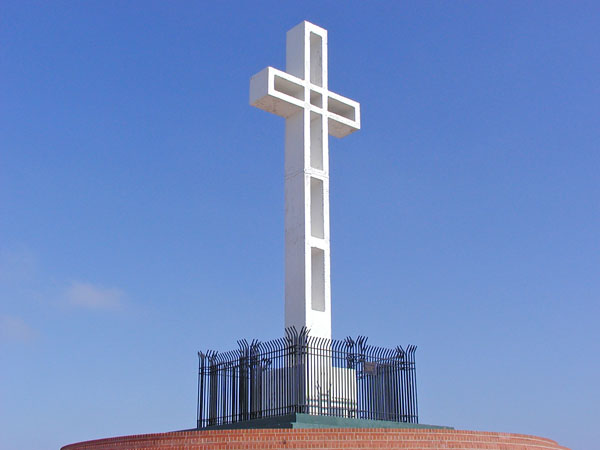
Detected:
left=250, top=21, right=360, bottom=339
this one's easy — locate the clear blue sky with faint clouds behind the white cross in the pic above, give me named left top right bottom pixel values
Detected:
left=0, top=1, right=600, bottom=450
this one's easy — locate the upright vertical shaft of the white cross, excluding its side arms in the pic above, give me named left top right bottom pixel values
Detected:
left=285, top=22, right=331, bottom=338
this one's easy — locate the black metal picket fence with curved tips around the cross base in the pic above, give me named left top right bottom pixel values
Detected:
left=197, top=328, right=418, bottom=428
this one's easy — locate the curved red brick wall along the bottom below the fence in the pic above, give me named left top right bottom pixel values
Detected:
left=62, top=428, right=569, bottom=450
